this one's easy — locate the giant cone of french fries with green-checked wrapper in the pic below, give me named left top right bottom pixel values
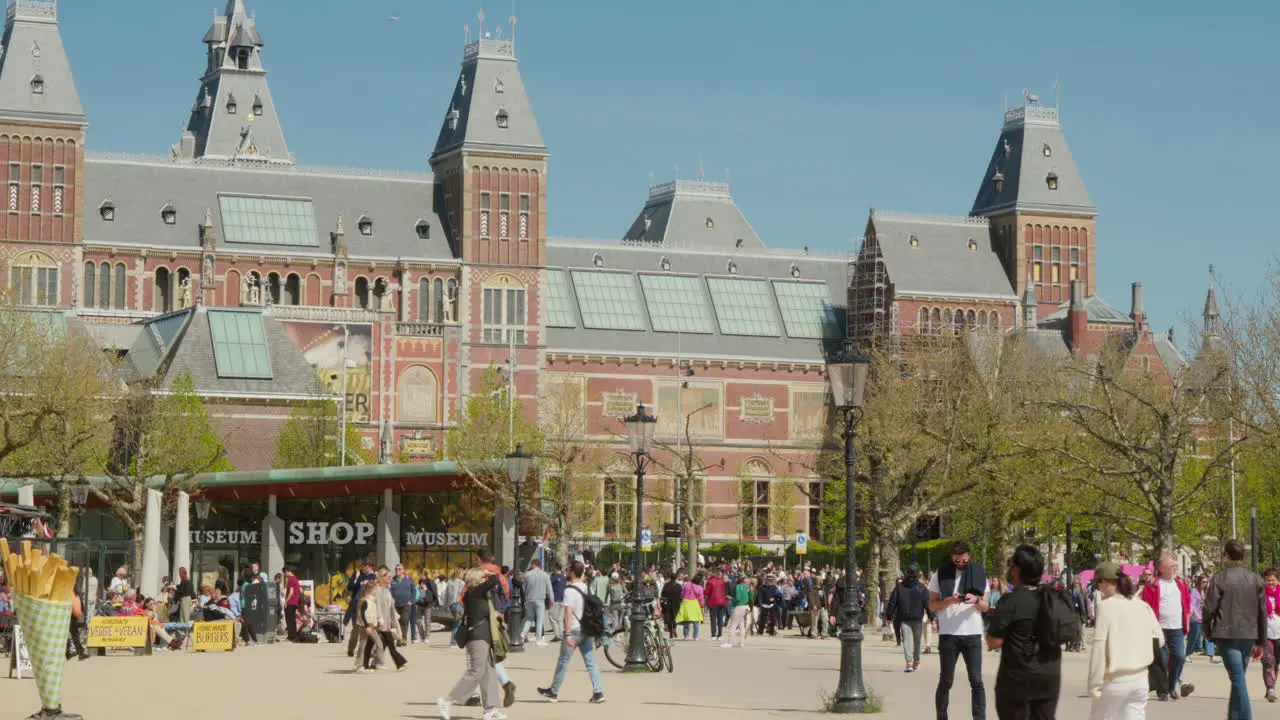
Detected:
left=0, top=538, right=79, bottom=720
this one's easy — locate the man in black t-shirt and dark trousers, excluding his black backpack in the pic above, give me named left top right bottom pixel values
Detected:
left=987, top=544, right=1062, bottom=720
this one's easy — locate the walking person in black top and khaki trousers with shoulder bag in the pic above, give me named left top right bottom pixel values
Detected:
left=435, top=568, right=507, bottom=720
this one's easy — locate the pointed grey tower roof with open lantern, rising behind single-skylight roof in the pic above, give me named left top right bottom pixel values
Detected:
left=173, top=0, right=293, bottom=164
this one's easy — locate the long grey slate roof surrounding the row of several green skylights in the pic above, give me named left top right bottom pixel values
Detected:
left=547, top=240, right=847, bottom=363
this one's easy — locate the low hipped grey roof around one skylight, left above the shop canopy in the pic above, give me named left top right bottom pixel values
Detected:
left=125, top=307, right=328, bottom=398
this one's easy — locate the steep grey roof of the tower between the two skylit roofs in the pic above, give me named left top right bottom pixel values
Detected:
left=431, top=38, right=547, bottom=158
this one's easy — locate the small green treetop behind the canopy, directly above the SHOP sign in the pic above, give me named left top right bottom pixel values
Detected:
left=275, top=398, right=374, bottom=468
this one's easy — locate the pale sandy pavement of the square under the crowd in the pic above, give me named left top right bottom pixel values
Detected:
left=12, top=634, right=1280, bottom=720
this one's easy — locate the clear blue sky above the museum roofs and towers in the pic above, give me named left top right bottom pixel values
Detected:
left=60, top=0, right=1280, bottom=335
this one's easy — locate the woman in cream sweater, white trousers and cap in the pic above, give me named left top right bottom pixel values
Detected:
left=1089, top=562, right=1165, bottom=720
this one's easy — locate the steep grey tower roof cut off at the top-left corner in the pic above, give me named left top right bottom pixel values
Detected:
left=0, top=0, right=84, bottom=126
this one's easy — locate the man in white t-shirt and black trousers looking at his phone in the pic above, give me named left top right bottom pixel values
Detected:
left=929, top=541, right=988, bottom=720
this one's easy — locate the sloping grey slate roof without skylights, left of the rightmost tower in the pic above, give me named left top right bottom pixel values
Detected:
left=868, top=211, right=1018, bottom=300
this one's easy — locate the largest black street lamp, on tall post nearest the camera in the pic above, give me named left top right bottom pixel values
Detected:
left=827, top=348, right=872, bottom=714
